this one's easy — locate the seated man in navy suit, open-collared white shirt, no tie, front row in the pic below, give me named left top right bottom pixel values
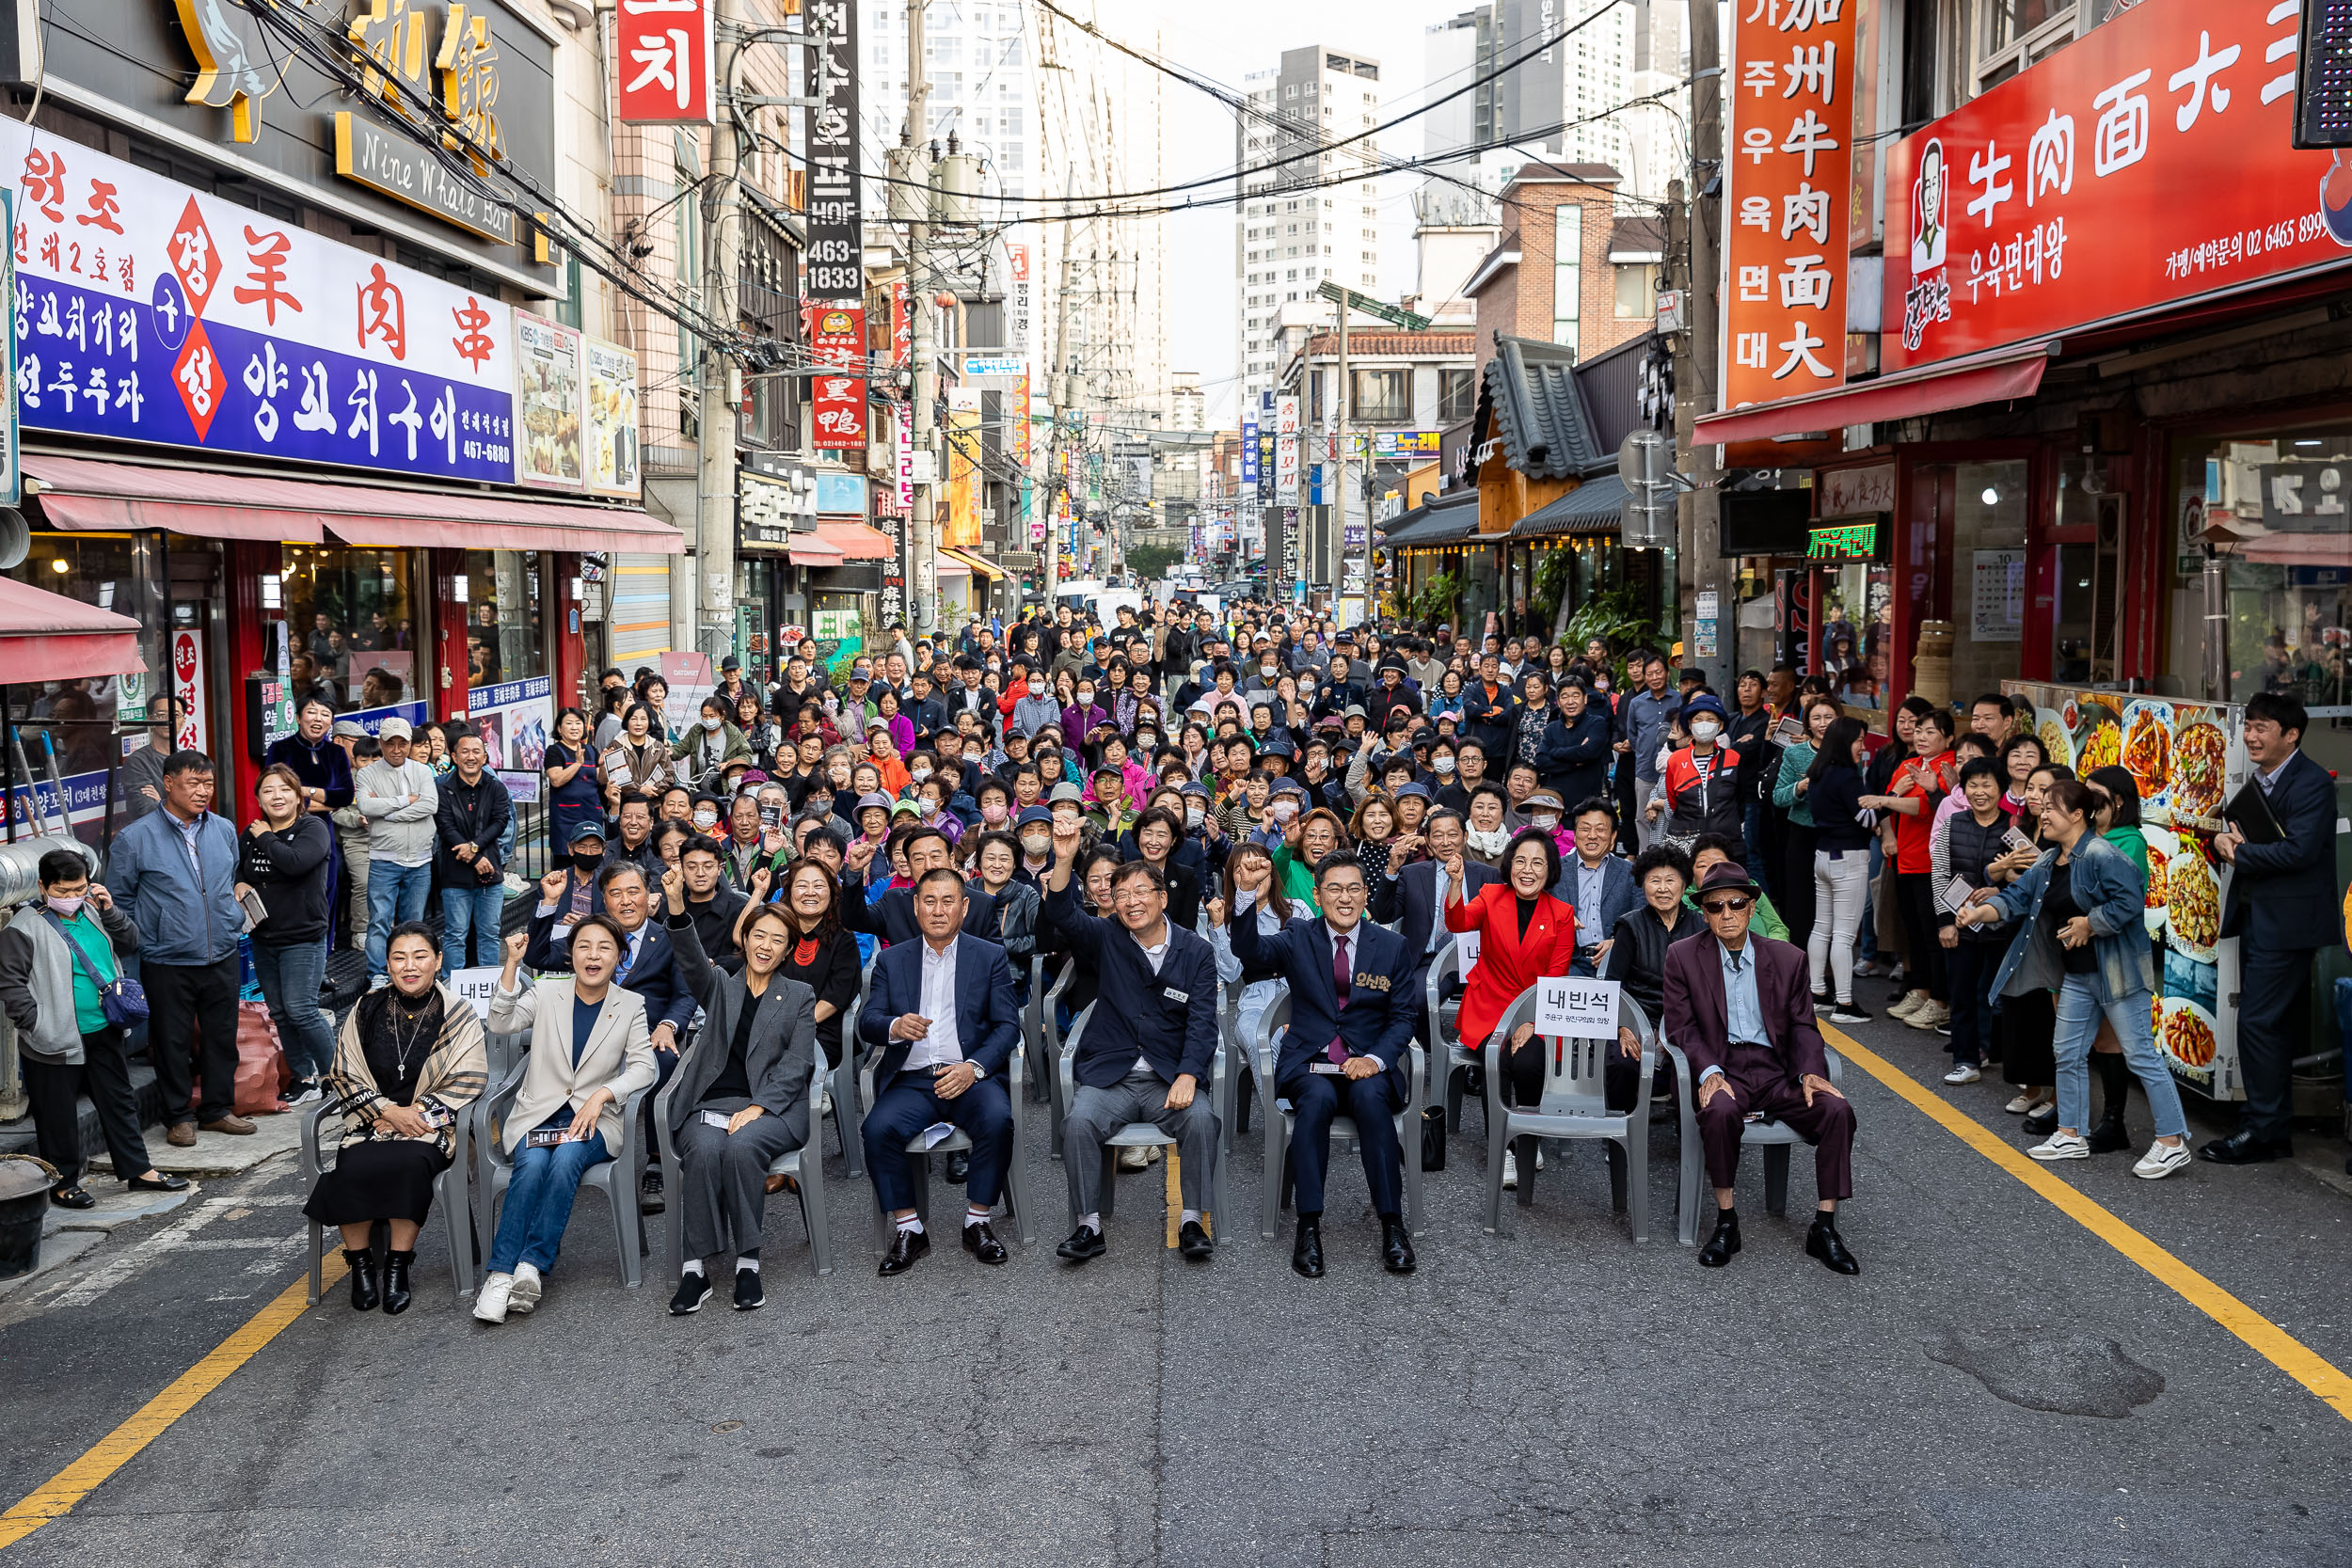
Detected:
left=859, top=865, right=1021, bottom=1276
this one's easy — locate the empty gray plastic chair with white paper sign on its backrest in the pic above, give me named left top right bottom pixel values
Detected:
left=1485, top=988, right=1696, bottom=1242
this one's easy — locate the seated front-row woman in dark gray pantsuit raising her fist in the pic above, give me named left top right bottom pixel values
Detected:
left=661, top=867, right=817, bottom=1317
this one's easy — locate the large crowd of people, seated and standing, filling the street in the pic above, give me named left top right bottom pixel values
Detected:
left=18, top=604, right=2333, bottom=1322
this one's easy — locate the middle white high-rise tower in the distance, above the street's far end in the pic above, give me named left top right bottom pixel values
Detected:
left=1232, top=44, right=1381, bottom=413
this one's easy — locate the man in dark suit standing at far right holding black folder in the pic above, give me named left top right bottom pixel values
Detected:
left=2197, top=691, right=2352, bottom=1171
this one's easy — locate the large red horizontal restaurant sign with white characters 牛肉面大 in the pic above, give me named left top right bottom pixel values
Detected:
left=1880, top=0, right=2352, bottom=369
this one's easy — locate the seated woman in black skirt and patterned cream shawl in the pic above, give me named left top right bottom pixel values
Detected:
left=304, top=919, right=489, bottom=1312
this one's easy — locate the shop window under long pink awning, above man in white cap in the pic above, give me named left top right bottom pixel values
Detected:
left=278, top=546, right=426, bottom=712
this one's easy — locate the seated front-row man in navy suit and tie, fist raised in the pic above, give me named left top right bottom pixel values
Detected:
left=1232, top=853, right=1421, bottom=1279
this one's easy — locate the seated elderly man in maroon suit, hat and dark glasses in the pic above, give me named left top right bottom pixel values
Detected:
left=1665, top=861, right=1863, bottom=1275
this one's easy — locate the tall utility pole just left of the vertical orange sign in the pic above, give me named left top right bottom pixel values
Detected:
left=1675, top=5, right=1736, bottom=691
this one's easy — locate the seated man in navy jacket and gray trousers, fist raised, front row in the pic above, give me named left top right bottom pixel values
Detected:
left=1042, top=816, right=1218, bottom=1262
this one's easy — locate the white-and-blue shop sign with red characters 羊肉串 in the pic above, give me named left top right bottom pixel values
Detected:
left=0, top=119, right=516, bottom=484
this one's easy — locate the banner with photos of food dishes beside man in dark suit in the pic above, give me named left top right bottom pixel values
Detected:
left=2002, top=682, right=2249, bottom=1101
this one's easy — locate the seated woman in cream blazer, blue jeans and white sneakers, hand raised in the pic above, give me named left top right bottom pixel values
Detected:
left=473, top=914, right=657, bottom=1323
